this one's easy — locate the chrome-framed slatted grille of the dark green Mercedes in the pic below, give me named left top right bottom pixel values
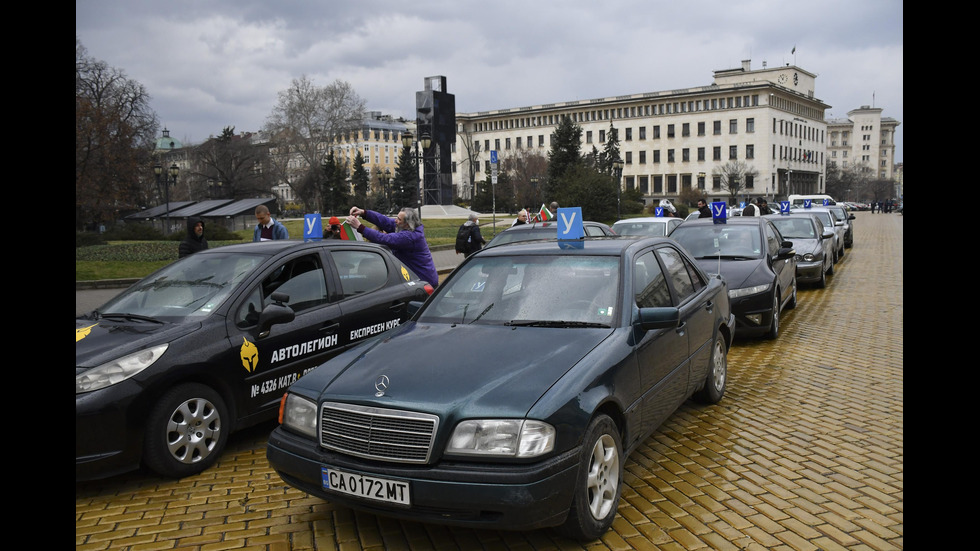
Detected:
left=320, top=402, right=439, bottom=463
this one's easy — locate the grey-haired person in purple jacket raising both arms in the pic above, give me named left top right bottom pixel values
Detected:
left=347, top=207, right=439, bottom=289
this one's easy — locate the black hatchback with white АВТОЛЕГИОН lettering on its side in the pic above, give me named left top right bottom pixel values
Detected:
left=82, top=240, right=432, bottom=480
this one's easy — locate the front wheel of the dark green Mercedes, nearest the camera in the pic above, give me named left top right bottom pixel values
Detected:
left=558, top=414, right=626, bottom=541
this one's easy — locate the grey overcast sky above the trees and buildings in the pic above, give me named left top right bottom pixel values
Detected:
left=75, top=0, right=905, bottom=162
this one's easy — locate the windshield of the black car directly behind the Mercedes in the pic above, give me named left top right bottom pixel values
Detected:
left=670, top=224, right=763, bottom=260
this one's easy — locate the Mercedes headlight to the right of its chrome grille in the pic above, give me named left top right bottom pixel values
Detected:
left=446, top=419, right=555, bottom=457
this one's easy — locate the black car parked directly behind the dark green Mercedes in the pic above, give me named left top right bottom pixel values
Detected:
left=670, top=216, right=797, bottom=339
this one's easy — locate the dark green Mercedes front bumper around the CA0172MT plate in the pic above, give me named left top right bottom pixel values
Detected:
left=266, top=427, right=580, bottom=530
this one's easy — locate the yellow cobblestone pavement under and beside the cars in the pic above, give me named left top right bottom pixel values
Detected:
left=75, top=212, right=905, bottom=551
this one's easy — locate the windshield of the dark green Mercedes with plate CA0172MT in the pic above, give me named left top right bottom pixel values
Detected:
left=418, top=255, right=620, bottom=327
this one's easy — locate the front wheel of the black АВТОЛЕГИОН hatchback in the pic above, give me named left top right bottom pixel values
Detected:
left=143, top=383, right=231, bottom=478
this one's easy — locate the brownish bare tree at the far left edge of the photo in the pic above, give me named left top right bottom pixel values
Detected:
left=75, top=37, right=159, bottom=230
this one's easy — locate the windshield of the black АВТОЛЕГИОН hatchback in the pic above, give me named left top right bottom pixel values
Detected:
left=97, top=253, right=268, bottom=323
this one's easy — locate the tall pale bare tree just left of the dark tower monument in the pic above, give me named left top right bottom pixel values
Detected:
left=265, top=75, right=365, bottom=213
